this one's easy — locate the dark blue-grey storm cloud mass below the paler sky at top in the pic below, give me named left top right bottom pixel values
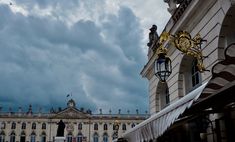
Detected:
left=0, top=1, right=147, bottom=111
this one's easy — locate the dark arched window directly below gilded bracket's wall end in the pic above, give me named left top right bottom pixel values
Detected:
left=191, top=60, right=200, bottom=88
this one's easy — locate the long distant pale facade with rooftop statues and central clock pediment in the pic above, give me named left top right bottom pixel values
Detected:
left=0, top=99, right=148, bottom=142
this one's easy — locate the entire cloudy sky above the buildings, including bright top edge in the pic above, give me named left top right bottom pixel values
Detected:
left=0, top=0, right=170, bottom=113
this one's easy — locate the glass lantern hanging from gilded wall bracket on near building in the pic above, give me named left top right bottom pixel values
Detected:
left=154, top=31, right=208, bottom=83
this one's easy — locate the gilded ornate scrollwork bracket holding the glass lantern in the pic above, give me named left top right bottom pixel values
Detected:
left=156, top=31, right=208, bottom=72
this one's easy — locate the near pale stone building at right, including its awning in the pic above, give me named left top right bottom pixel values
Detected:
left=122, top=0, right=235, bottom=142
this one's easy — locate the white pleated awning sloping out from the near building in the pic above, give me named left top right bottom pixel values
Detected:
left=122, top=83, right=207, bottom=142
